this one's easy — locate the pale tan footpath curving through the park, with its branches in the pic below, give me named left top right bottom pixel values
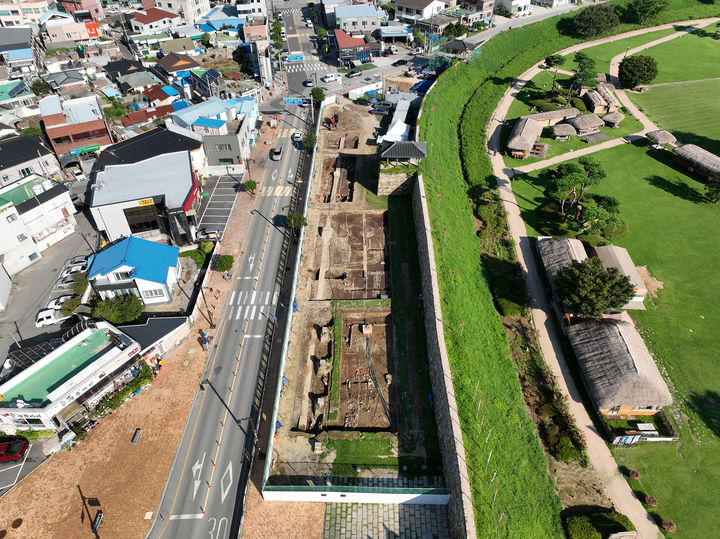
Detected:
left=488, top=18, right=720, bottom=539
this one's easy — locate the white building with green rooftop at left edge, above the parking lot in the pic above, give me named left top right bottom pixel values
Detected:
left=0, top=174, right=76, bottom=275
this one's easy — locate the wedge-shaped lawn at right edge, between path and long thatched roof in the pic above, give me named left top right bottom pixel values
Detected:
left=628, top=78, right=720, bottom=154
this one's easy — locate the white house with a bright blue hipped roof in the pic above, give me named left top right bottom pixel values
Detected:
left=87, top=236, right=182, bottom=305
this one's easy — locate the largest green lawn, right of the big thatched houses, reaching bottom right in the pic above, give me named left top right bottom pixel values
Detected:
left=513, top=144, right=720, bottom=537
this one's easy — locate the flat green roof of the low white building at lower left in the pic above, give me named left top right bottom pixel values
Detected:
left=0, top=329, right=114, bottom=406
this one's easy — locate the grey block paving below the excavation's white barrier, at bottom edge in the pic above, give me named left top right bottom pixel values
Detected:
left=323, top=503, right=450, bottom=539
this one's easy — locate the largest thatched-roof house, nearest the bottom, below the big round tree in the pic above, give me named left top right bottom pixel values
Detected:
left=567, top=319, right=672, bottom=415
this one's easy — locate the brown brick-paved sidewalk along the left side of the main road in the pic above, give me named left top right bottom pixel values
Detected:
left=0, top=180, right=252, bottom=539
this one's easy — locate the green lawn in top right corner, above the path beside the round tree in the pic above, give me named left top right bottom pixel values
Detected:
left=641, top=29, right=720, bottom=84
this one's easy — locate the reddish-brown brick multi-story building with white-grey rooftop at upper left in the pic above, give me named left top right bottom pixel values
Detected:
left=39, top=95, right=112, bottom=166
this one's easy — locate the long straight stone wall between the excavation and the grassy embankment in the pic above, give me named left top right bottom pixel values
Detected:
left=412, top=176, right=475, bottom=537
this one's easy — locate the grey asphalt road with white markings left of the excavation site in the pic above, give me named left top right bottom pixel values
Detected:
left=148, top=96, right=307, bottom=539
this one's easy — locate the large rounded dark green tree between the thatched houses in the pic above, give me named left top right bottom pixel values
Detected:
left=555, top=257, right=635, bottom=318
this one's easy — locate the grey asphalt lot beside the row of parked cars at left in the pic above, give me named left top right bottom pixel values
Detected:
left=0, top=213, right=97, bottom=359
